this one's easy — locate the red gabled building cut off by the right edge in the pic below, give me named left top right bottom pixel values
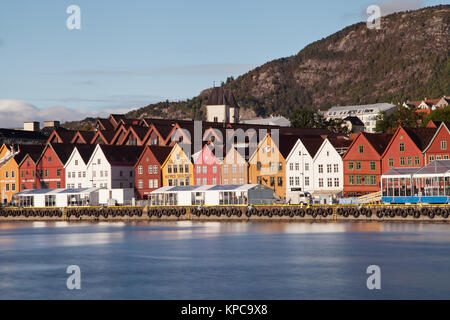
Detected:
left=423, top=122, right=450, bottom=165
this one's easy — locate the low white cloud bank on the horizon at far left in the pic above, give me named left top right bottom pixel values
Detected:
left=0, top=99, right=106, bottom=128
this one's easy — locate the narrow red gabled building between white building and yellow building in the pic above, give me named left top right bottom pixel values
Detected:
left=134, top=145, right=172, bottom=199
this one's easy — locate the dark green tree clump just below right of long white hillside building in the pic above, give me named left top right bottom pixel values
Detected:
left=375, top=106, right=422, bottom=133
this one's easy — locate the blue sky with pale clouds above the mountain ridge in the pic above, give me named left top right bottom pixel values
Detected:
left=0, top=0, right=449, bottom=127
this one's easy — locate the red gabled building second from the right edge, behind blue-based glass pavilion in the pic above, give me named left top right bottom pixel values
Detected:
left=381, top=126, right=437, bottom=173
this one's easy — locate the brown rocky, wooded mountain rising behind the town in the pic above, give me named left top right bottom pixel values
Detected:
left=65, top=5, right=450, bottom=127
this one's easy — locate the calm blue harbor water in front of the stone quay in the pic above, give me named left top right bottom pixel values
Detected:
left=0, top=221, right=450, bottom=300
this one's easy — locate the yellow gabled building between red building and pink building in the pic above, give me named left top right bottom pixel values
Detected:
left=161, top=144, right=194, bottom=186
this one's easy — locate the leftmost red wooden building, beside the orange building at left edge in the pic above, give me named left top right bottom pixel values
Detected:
left=19, top=145, right=45, bottom=191
